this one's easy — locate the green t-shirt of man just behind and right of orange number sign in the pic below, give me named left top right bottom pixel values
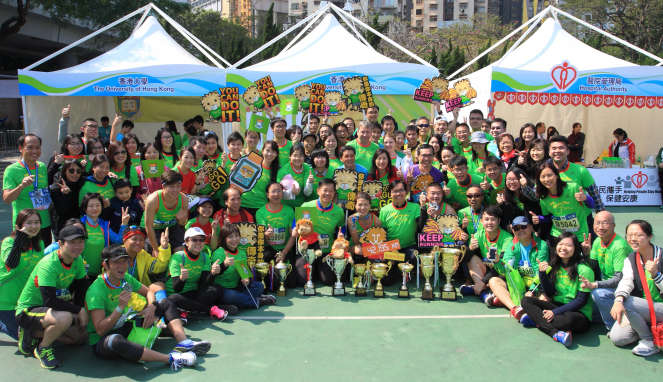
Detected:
left=380, top=202, right=421, bottom=248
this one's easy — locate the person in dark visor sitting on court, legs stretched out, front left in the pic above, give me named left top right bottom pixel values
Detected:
left=85, top=245, right=212, bottom=370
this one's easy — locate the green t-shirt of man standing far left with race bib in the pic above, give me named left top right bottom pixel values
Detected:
left=2, top=161, right=51, bottom=228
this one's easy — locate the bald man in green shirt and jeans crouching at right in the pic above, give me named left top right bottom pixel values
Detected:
left=582, top=211, right=632, bottom=330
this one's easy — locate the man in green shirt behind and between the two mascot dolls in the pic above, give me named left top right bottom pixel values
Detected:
left=295, top=178, right=342, bottom=285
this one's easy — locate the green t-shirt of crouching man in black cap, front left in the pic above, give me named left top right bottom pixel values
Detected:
left=16, top=251, right=85, bottom=314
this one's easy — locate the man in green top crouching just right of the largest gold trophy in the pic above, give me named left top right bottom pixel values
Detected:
left=460, top=206, right=513, bottom=302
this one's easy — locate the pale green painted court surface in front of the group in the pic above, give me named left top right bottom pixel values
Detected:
left=0, top=204, right=663, bottom=382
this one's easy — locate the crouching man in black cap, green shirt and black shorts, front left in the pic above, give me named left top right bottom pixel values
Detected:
left=16, top=225, right=89, bottom=369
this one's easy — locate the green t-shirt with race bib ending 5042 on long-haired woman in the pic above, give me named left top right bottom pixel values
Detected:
left=541, top=183, right=589, bottom=242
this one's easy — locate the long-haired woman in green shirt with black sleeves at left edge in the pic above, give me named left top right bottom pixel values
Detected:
left=0, top=208, right=44, bottom=341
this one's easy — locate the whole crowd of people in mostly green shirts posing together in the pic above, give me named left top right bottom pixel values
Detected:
left=0, top=103, right=663, bottom=369
